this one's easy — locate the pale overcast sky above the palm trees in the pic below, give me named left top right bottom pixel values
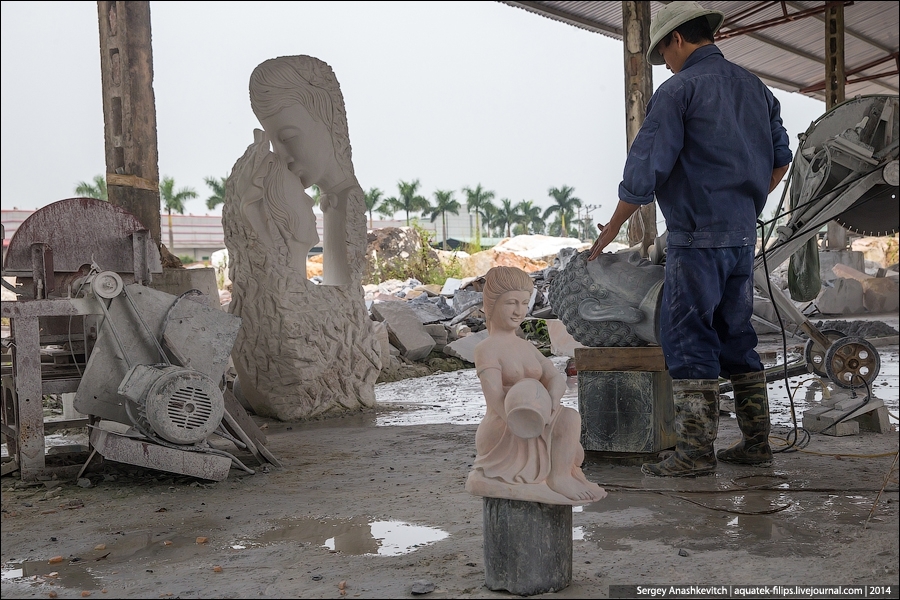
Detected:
left=0, top=1, right=825, bottom=230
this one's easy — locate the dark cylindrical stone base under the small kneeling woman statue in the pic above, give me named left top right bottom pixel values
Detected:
left=484, top=497, right=572, bottom=596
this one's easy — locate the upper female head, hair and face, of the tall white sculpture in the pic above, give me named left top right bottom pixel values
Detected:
left=250, top=55, right=353, bottom=189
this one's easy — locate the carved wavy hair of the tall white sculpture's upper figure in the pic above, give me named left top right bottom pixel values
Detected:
left=250, top=55, right=354, bottom=174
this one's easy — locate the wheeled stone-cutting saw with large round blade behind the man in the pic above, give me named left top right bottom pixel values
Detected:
left=754, top=95, right=900, bottom=388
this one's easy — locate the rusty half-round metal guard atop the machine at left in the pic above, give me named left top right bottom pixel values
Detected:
left=4, top=198, right=162, bottom=277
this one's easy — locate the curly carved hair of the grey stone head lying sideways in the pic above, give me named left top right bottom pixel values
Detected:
left=547, top=250, right=647, bottom=347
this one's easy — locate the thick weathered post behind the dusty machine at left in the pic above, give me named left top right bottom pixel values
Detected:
left=97, top=1, right=161, bottom=247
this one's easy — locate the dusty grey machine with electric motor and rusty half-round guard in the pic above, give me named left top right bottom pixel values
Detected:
left=2, top=198, right=278, bottom=480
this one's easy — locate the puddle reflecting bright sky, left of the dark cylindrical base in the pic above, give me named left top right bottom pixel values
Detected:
left=239, top=517, right=450, bottom=556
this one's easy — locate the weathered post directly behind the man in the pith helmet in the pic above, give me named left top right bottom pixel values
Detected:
left=622, top=2, right=656, bottom=257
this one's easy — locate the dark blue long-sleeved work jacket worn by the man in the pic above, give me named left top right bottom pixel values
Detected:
left=619, top=44, right=791, bottom=248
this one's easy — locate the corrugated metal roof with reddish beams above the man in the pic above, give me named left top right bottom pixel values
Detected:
left=501, top=0, right=900, bottom=100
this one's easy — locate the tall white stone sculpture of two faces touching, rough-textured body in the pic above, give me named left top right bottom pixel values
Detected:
left=222, top=56, right=381, bottom=421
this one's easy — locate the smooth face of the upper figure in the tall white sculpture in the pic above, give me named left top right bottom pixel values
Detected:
left=260, top=104, right=336, bottom=188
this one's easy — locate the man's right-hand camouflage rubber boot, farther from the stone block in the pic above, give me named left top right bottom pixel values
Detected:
left=716, top=371, right=772, bottom=467
